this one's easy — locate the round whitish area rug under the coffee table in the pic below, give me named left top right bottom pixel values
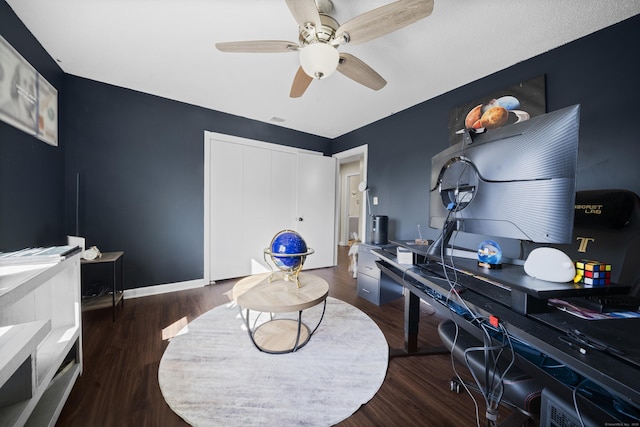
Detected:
left=158, top=297, right=389, bottom=426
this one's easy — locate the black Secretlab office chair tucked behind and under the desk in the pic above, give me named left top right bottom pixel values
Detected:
left=438, top=190, right=640, bottom=426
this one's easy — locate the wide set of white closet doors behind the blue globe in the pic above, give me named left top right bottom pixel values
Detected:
left=208, top=138, right=335, bottom=282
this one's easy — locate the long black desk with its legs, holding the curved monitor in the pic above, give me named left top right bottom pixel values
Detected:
left=374, top=246, right=640, bottom=422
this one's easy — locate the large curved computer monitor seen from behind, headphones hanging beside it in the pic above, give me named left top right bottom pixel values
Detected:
left=429, top=105, right=580, bottom=255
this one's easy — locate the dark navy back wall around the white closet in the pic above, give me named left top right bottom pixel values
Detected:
left=64, top=76, right=331, bottom=287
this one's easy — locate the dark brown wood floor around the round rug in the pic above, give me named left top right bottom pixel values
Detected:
left=57, top=248, right=520, bottom=427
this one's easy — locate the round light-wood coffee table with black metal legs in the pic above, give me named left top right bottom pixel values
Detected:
left=233, top=273, right=329, bottom=354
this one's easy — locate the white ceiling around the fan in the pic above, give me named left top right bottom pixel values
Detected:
left=6, top=0, right=640, bottom=138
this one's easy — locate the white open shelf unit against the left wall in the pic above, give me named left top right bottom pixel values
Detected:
left=0, top=251, right=82, bottom=426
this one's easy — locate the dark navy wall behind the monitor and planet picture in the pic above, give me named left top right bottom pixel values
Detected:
left=333, top=16, right=640, bottom=251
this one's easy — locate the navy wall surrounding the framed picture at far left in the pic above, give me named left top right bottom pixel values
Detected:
left=0, top=1, right=66, bottom=251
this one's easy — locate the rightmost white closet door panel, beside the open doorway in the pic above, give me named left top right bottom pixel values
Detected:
left=297, top=153, right=336, bottom=270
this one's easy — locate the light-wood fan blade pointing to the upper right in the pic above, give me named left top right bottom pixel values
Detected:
left=335, top=0, right=433, bottom=44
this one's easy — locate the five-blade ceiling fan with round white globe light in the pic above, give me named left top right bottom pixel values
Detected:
left=216, top=0, right=433, bottom=98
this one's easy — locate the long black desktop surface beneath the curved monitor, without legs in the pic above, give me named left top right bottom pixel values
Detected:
left=373, top=249, right=640, bottom=408
